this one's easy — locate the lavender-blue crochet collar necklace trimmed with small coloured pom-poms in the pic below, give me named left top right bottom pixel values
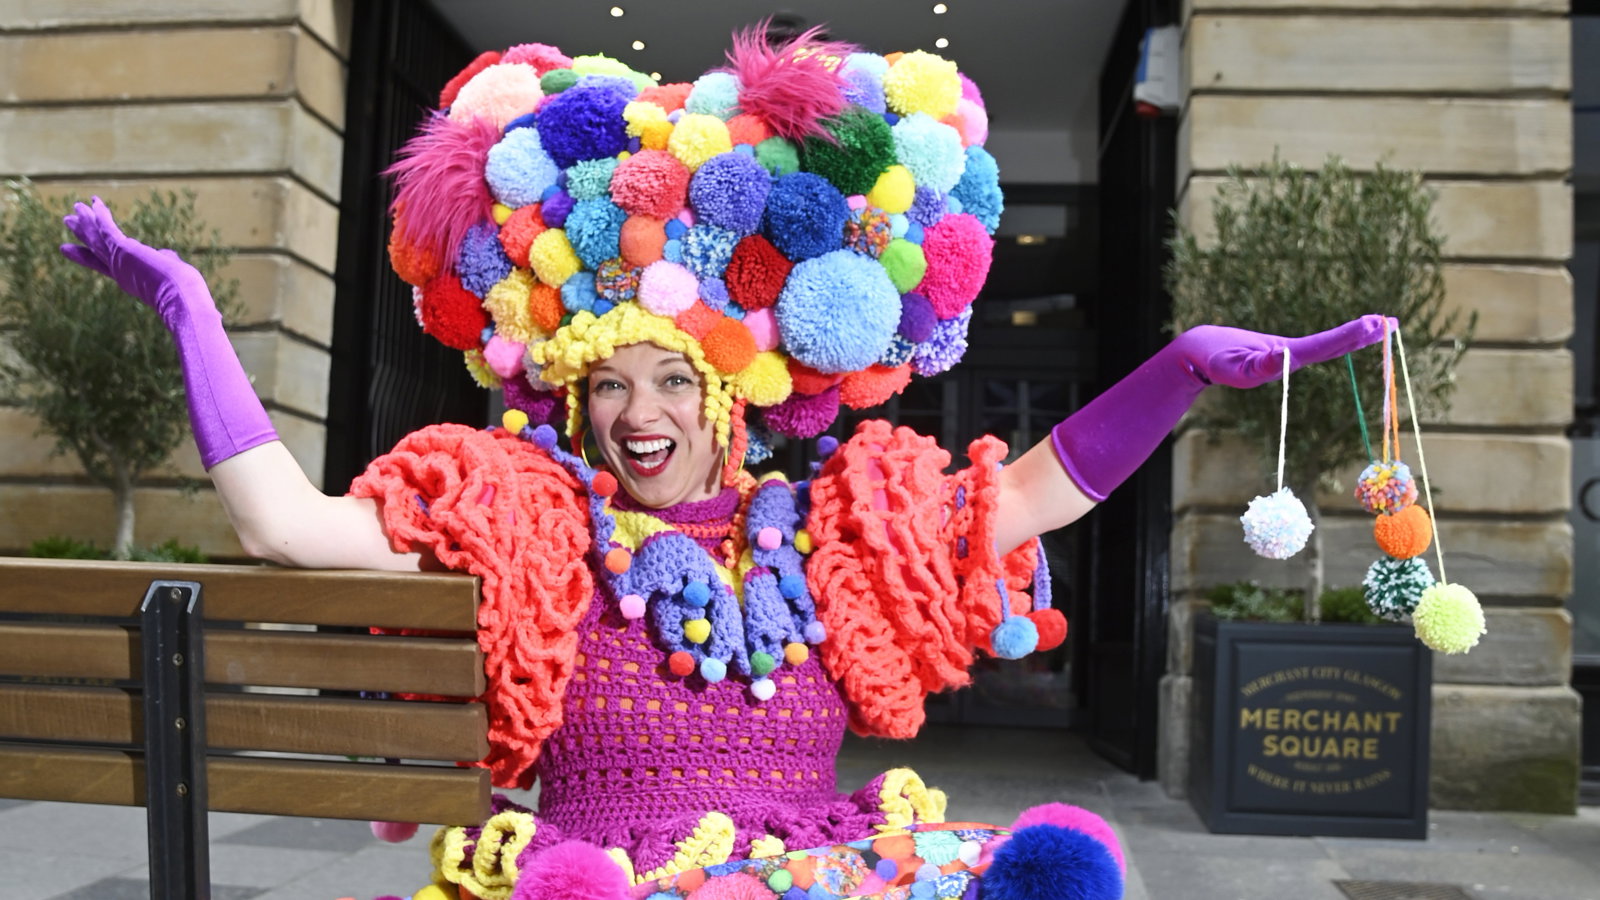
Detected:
left=502, top=410, right=827, bottom=700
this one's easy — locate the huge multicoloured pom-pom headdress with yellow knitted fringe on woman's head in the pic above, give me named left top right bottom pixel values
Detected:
left=389, top=29, right=1003, bottom=461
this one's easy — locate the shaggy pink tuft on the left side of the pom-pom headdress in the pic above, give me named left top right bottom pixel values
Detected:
left=384, top=114, right=501, bottom=266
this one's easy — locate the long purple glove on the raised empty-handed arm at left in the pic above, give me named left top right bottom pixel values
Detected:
left=61, top=197, right=278, bottom=469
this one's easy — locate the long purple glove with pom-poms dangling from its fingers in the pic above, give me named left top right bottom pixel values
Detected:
left=1050, top=315, right=1397, bottom=503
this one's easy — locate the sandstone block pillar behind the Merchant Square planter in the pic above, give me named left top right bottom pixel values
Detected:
left=1162, top=0, right=1579, bottom=812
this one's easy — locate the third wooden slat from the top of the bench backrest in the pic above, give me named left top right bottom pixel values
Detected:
left=0, top=684, right=488, bottom=762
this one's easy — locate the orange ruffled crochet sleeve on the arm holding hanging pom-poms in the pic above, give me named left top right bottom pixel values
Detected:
left=806, top=420, right=1038, bottom=738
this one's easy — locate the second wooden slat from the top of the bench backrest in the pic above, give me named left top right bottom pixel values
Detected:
left=0, top=621, right=485, bottom=697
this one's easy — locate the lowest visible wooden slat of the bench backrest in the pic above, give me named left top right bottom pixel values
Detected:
left=0, top=743, right=490, bottom=825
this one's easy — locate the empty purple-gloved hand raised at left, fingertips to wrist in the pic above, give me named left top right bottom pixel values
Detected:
left=61, top=197, right=216, bottom=330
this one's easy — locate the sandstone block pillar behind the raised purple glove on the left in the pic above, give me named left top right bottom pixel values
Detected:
left=0, top=0, right=352, bottom=557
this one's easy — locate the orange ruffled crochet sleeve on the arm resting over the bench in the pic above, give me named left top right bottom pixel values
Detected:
left=350, top=424, right=594, bottom=788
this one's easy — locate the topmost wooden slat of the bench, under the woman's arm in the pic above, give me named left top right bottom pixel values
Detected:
left=0, top=557, right=477, bottom=631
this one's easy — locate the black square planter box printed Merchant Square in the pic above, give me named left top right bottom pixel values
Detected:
left=1189, top=613, right=1434, bottom=838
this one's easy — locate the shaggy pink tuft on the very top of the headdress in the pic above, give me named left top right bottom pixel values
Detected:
left=723, top=21, right=856, bottom=141
